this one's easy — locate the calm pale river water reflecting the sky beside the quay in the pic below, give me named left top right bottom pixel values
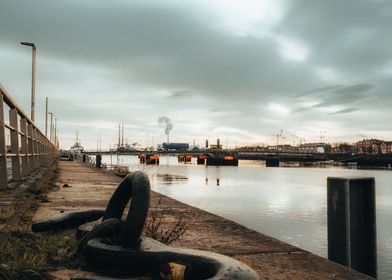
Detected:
left=103, top=155, right=392, bottom=279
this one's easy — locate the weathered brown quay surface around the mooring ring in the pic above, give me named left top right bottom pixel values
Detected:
left=33, top=161, right=373, bottom=280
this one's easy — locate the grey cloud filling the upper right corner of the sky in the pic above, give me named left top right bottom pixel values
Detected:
left=277, top=0, right=392, bottom=75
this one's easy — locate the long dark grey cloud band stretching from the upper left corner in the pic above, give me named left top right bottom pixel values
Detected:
left=0, top=1, right=316, bottom=102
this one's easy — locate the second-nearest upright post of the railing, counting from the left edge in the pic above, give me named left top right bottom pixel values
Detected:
left=9, top=109, right=21, bottom=180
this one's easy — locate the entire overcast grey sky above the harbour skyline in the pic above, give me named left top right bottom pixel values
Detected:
left=0, top=0, right=392, bottom=148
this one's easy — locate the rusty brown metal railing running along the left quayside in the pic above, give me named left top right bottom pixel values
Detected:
left=0, top=84, right=58, bottom=190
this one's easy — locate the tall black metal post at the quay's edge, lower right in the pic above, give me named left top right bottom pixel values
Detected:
left=327, top=177, right=377, bottom=277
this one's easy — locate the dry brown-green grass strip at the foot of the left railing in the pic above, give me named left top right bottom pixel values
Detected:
left=0, top=161, right=79, bottom=280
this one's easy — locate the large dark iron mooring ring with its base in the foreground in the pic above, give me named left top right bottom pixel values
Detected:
left=75, top=172, right=259, bottom=280
